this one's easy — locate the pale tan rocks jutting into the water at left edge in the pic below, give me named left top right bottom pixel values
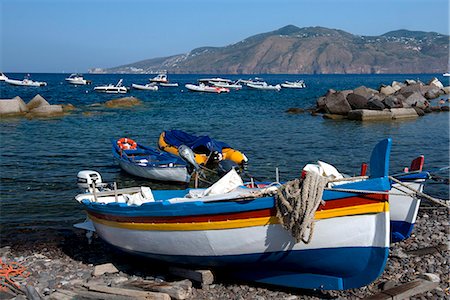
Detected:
left=0, top=94, right=72, bottom=118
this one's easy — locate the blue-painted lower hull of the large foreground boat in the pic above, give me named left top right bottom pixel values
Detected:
left=111, top=247, right=389, bottom=290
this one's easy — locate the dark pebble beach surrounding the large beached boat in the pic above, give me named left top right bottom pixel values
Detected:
left=0, top=201, right=450, bottom=300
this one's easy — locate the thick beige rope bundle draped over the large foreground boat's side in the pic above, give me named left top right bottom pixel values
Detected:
left=275, top=172, right=327, bottom=244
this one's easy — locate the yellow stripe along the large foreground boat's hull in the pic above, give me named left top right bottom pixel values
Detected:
left=89, top=202, right=389, bottom=231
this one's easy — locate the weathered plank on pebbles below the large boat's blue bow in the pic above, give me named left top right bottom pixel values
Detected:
left=365, top=279, right=439, bottom=300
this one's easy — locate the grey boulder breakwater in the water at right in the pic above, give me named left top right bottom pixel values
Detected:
left=315, top=78, right=450, bottom=121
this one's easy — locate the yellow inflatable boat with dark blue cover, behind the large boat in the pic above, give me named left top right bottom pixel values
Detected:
left=158, top=130, right=248, bottom=167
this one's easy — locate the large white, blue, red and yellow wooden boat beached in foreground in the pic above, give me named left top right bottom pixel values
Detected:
left=76, top=139, right=392, bottom=290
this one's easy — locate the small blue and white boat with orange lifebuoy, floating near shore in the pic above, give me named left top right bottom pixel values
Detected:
left=111, top=138, right=193, bottom=183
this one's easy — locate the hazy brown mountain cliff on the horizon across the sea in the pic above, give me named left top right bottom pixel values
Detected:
left=100, top=25, right=449, bottom=74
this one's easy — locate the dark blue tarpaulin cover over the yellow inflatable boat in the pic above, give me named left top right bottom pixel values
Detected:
left=164, top=130, right=231, bottom=154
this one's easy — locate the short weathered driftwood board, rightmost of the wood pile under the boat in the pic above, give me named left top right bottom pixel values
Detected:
left=127, top=279, right=192, bottom=300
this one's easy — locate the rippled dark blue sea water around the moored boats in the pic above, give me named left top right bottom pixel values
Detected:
left=0, top=74, right=449, bottom=238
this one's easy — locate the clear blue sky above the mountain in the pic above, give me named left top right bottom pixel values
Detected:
left=0, top=0, right=450, bottom=73
